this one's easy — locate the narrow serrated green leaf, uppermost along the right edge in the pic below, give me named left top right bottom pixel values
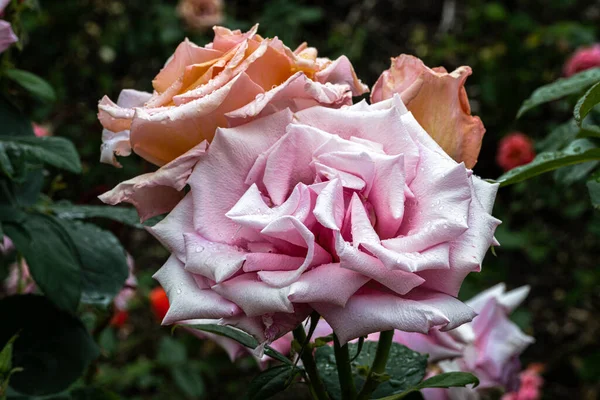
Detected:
left=517, top=68, right=600, bottom=118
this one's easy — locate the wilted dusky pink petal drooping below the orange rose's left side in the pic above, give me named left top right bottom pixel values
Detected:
left=100, top=142, right=207, bottom=222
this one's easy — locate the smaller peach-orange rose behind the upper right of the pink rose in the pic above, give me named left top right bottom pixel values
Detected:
left=371, top=54, right=485, bottom=168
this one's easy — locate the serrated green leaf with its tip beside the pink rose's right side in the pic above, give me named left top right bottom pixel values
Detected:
left=497, top=139, right=600, bottom=186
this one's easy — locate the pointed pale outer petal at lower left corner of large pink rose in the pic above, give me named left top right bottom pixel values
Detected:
left=154, top=256, right=240, bottom=325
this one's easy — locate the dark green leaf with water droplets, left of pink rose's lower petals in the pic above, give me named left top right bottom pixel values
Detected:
left=60, top=220, right=129, bottom=306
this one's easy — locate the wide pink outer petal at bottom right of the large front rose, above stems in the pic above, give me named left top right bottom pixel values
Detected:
left=311, top=289, right=475, bottom=343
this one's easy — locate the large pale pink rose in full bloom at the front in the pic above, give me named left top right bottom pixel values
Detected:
left=139, top=96, right=499, bottom=343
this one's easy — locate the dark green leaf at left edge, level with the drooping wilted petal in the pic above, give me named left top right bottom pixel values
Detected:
left=0, top=136, right=81, bottom=176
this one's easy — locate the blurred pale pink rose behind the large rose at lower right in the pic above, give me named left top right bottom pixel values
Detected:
left=394, top=284, right=534, bottom=400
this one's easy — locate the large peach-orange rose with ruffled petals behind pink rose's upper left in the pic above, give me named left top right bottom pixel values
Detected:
left=98, top=26, right=368, bottom=166
